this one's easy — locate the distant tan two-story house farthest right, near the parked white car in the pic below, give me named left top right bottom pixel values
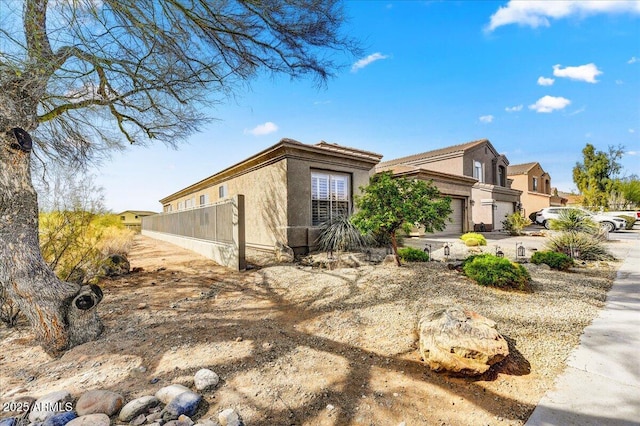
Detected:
left=507, top=162, right=567, bottom=216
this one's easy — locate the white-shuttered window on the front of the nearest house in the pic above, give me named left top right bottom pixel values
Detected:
left=311, top=171, right=351, bottom=226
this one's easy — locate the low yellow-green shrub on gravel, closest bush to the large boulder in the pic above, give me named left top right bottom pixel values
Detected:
left=462, top=254, right=531, bottom=290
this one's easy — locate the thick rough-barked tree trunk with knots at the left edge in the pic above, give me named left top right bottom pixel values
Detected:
left=0, top=128, right=102, bottom=355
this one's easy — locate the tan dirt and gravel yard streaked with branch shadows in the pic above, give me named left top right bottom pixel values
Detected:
left=0, top=236, right=617, bottom=426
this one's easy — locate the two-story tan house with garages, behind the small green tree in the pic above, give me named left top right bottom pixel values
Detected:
left=377, top=139, right=522, bottom=231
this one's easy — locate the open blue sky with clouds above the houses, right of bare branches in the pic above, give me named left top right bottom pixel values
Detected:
left=96, top=1, right=640, bottom=212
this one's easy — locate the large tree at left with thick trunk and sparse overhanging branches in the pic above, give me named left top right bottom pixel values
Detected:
left=0, top=0, right=357, bottom=354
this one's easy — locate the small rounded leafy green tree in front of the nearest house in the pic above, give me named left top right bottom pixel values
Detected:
left=352, top=172, right=452, bottom=266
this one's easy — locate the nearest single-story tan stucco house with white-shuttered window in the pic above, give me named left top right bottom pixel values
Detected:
left=160, top=139, right=382, bottom=256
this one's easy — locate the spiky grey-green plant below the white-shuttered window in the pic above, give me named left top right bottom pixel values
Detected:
left=316, top=215, right=370, bottom=252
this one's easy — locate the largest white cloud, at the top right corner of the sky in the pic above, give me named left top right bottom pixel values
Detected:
left=485, top=0, right=640, bottom=31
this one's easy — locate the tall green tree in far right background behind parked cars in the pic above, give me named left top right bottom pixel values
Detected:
left=573, top=144, right=624, bottom=208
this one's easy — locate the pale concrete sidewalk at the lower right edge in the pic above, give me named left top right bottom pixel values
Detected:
left=526, top=235, right=640, bottom=426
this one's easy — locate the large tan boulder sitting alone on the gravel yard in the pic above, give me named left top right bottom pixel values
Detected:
left=418, top=306, right=509, bottom=376
